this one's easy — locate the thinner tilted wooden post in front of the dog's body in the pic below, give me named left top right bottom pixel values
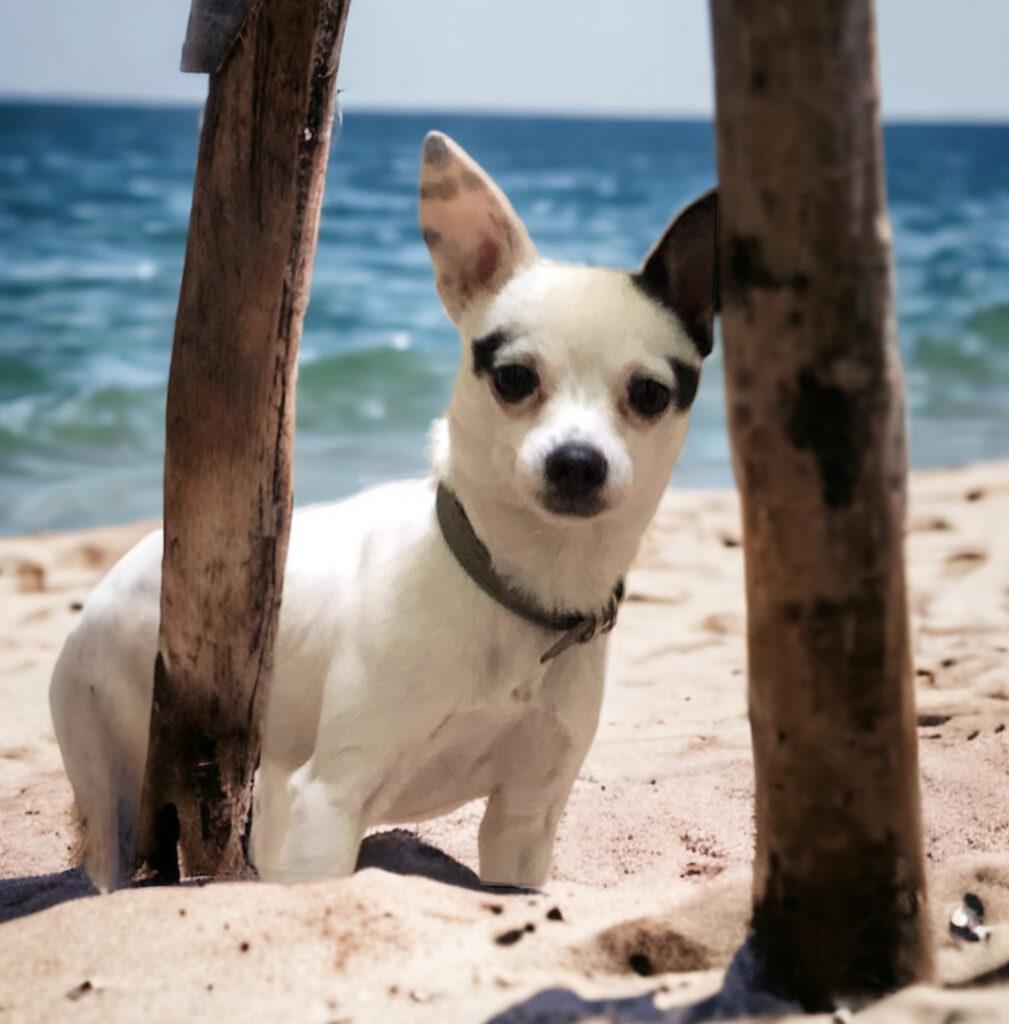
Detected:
left=137, top=0, right=349, bottom=880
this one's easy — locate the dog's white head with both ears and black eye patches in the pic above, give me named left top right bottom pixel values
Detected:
left=420, top=132, right=717, bottom=519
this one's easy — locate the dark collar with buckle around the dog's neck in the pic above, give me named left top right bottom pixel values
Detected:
left=434, top=483, right=624, bottom=665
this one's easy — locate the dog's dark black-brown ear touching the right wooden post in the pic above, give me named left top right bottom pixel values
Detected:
left=633, top=188, right=718, bottom=355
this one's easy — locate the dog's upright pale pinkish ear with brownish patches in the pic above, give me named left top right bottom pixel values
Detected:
left=420, top=132, right=536, bottom=322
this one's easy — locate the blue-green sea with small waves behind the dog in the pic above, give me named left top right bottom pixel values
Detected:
left=0, top=103, right=1009, bottom=534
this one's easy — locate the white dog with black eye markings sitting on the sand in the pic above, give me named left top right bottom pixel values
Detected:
left=50, top=133, right=716, bottom=889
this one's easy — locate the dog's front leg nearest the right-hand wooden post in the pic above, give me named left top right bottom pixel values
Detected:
left=479, top=640, right=605, bottom=887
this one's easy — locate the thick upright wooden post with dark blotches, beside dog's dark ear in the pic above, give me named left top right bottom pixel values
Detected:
left=711, top=0, right=930, bottom=1010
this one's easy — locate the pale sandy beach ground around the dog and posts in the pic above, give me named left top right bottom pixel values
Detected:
left=0, top=464, right=1009, bottom=1024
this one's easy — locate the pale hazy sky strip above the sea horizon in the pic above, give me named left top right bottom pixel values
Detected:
left=0, top=0, right=1009, bottom=120
